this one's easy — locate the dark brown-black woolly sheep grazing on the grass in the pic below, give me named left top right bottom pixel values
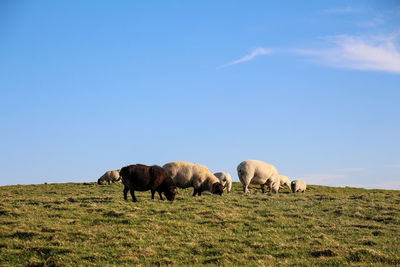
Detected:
left=120, top=164, right=177, bottom=202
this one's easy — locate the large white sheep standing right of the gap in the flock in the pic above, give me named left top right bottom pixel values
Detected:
left=237, top=160, right=279, bottom=193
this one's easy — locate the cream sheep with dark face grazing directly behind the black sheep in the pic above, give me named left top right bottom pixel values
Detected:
left=163, top=161, right=224, bottom=196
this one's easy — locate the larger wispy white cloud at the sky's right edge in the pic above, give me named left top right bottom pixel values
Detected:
left=295, top=33, right=400, bottom=73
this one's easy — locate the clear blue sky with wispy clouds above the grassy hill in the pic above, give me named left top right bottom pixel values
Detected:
left=0, top=0, right=400, bottom=189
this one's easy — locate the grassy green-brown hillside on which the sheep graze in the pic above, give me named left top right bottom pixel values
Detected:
left=0, top=183, right=400, bottom=266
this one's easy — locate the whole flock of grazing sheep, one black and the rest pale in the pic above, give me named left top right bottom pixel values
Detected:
left=97, top=160, right=306, bottom=201
